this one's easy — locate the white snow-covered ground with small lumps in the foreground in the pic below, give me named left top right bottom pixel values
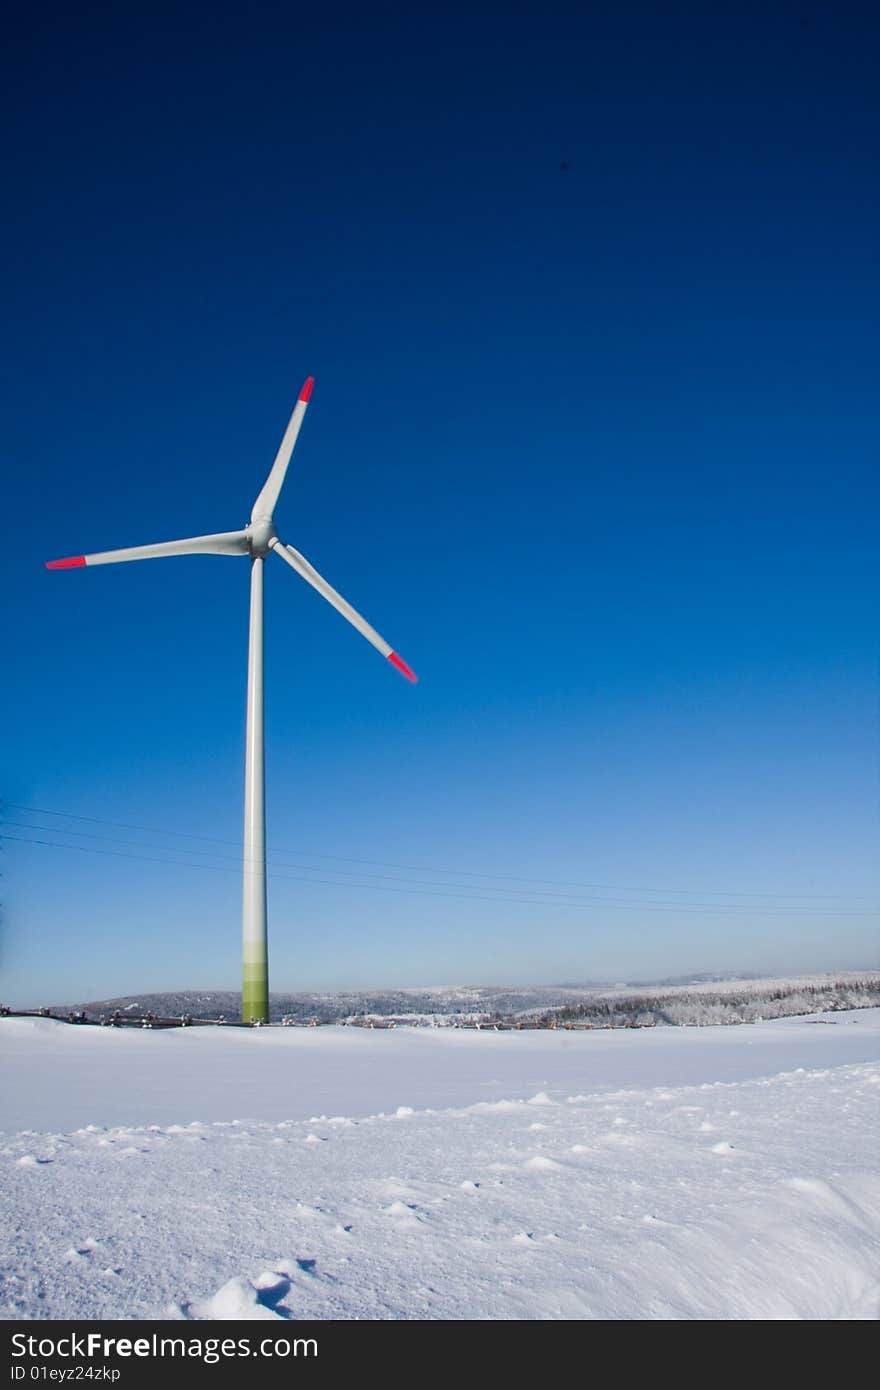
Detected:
left=0, top=1009, right=880, bottom=1319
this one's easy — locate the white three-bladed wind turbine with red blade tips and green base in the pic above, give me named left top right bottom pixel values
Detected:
left=46, top=377, right=417, bottom=1023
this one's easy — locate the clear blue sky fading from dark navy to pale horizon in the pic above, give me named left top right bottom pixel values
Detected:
left=1, top=3, right=880, bottom=1002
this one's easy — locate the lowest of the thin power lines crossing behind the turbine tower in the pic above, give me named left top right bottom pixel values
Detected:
left=0, top=834, right=876, bottom=917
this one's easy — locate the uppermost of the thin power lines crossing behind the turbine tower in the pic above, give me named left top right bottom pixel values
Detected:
left=6, top=801, right=873, bottom=902
